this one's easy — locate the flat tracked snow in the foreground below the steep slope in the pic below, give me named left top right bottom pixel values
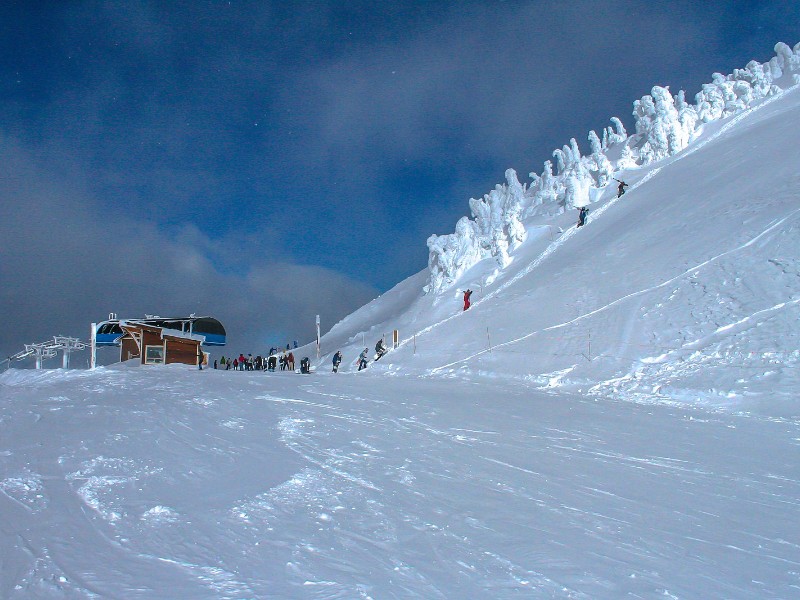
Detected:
left=0, top=365, right=800, bottom=600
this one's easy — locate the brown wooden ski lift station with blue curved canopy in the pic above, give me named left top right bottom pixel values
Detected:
left=93, top=315, right=225, bottom=365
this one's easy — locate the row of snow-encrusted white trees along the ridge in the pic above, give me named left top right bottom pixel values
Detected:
left=426, top=43, right=800, bottom=292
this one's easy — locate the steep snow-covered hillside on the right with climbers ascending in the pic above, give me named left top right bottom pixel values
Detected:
left=322, top=78, right=800, bottom=414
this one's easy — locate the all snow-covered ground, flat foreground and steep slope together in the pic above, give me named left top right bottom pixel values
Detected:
left=0, top=64, right=800, bottom=599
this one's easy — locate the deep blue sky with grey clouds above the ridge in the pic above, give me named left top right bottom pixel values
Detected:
left=0, top=0, right=800, bottom=355
